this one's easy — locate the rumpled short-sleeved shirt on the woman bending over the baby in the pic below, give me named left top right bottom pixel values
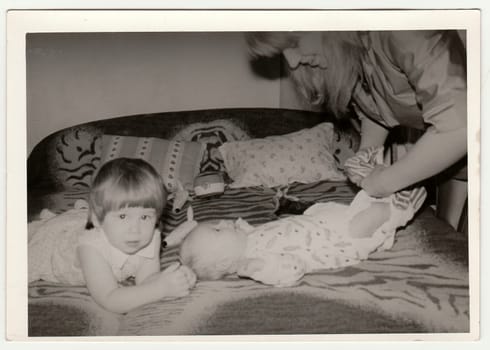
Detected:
left=385, top=31, right=467, bottom=132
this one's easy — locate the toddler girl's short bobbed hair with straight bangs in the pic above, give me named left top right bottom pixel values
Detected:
left=89, top=158, right=167, bottom=222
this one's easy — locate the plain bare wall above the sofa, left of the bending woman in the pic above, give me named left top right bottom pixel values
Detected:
left=26, top=33, right=288, bottom=153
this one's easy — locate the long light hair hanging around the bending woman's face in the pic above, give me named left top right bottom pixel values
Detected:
left=246, top=32, right=364, bottom=117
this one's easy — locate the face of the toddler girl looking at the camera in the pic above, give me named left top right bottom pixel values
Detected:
left=100, top=207, right=157, bottom=254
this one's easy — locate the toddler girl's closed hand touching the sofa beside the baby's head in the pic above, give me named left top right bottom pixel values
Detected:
left=158, top=263, right=196, bottom=298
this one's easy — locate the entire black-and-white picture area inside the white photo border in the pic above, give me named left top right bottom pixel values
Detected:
left=5, top=11, right=479, bottom=340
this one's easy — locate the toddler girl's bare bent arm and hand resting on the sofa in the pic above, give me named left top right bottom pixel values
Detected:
left=78, top=241, right=195, bottom=313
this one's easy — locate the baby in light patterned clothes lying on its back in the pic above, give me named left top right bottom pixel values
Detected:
left=176, top=188, right=426, bottom=287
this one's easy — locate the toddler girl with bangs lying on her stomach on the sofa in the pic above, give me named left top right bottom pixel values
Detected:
left=28, top=158, right=196, bottom=313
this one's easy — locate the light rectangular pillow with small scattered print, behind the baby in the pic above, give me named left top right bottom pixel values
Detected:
left=219, top=123, right=346, bottom=188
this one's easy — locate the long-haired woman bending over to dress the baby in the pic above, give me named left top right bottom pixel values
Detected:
left=247, top=30, right=467, bottom=197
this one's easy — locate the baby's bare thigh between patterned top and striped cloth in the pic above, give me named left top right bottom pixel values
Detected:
left=349, top=202, right=390, bottom=238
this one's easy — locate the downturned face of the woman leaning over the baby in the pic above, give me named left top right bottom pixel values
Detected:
left=282, top=32, right=327, bottom=69
